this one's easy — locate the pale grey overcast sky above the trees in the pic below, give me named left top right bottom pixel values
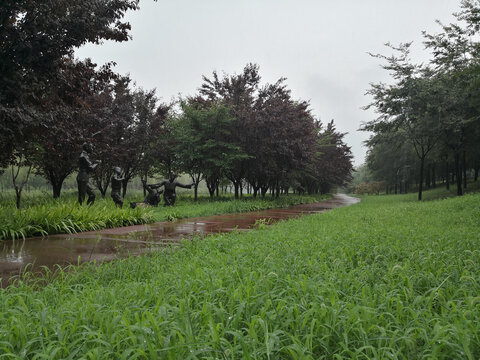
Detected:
left=76, top=0, right=460, bottom=166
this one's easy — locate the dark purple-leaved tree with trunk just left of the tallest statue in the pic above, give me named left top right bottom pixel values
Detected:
left=31, top=59, right=115, bottom=198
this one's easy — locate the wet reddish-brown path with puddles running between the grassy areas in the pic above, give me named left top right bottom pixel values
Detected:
left=0, top=194, right=359, bottom=286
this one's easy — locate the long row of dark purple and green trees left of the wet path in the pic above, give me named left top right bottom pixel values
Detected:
left=0, top=0, right=352, bottom=206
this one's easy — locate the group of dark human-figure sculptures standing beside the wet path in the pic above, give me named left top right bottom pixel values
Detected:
left=77, top=143, right=193, bottom=208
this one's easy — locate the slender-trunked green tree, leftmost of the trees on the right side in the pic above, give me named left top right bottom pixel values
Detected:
left=362, top=43, right=443, bottom=200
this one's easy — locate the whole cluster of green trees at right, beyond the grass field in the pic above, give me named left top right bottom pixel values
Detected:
left=362, top=0, right=480, bottom=200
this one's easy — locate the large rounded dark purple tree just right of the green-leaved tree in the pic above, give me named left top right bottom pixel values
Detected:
left=247, top=78, right=315, bottom=196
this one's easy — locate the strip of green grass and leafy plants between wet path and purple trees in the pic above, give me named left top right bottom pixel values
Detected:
left=0, top=191, right=326, bottom=240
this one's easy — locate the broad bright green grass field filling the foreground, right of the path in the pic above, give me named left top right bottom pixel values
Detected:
left=0, top=191, right=480, bottom=359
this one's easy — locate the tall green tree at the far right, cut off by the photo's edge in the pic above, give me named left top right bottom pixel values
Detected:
left=424, top=0, right=480, bottom=195
